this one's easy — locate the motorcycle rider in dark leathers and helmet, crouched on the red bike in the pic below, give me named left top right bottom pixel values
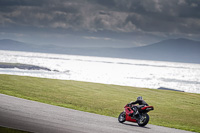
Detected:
left=128, top=96, right=149, bottom=116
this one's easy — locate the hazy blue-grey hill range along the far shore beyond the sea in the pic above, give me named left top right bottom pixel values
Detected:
left=0, top=38, right=200, bottom=64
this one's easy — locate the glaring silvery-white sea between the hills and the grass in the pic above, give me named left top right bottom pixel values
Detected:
left=0, top=50, right=200, bottom=93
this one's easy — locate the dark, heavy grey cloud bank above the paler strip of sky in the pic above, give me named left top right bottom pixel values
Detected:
left=0, top=0, right=200, bottom=43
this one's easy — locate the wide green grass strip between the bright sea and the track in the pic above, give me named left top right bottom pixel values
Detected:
left=0, top=75, right=200, bottom=132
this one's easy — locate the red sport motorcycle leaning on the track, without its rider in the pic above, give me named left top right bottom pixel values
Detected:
left=118, top=104, right=154, bottom=127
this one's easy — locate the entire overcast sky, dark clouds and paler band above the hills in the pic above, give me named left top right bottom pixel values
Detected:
left=0, top=0, right=200, bottom=47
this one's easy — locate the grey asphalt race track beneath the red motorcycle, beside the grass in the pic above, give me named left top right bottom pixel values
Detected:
left=0, top=94, right=194, bottom=133
